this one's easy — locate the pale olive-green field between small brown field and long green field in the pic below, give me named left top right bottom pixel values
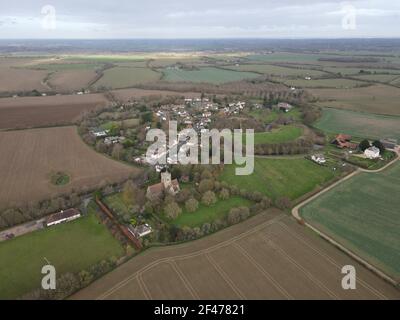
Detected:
left=93, top=67, right=161, bottom=89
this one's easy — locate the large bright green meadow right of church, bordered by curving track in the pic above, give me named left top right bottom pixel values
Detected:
left=220, top=157, right=335, bottom=200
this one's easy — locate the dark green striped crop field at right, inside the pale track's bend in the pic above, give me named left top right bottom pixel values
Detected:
left=300, top=163, right=400, bottom=280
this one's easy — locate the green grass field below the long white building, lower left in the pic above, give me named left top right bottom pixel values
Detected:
left=0, top=208, right=124, bottom=299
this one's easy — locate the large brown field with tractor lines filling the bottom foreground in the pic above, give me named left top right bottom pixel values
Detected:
left=71, top=209, right=400, bottom=300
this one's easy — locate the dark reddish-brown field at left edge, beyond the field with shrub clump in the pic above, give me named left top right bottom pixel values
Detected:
left=0, top=94, right=107, bottom=130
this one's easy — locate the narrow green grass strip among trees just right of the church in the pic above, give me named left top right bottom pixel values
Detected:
left=172, top=196, right=252, bottom=228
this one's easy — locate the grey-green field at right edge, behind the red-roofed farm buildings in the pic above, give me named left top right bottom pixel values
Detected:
left=314, top=108, right=400, bottom=141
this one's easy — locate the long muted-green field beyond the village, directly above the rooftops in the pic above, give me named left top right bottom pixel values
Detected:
left=163, top=67, right=260, bottom=84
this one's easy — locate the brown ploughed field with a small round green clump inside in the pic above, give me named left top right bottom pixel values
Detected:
left=0, top=126, right=139, bottom=208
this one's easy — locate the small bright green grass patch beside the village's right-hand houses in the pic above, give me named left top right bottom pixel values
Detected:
left=247, top=126, right=303, bottom=144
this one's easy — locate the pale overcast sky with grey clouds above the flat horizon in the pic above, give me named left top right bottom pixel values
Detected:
left=0, top=0, right=400, bottom=39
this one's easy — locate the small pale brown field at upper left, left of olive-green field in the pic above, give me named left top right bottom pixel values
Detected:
left=48, top=69, right=97, bottom=92
